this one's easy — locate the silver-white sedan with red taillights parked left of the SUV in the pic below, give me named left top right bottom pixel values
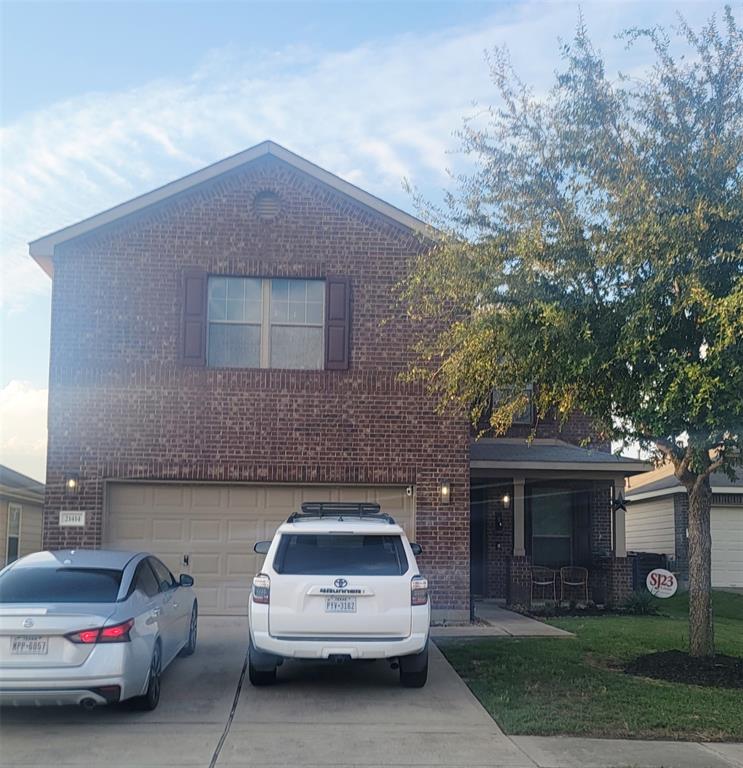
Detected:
left=0, top=549, right=198, bottom=710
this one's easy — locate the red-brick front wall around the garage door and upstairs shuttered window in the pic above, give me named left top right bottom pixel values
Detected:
left=44, top=158, right=469, bottom=609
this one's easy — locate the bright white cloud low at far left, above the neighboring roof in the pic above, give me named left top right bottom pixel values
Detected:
left=0, top=380, right=48, bottom=482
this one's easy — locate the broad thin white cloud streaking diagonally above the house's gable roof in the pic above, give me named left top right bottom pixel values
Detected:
left=0, top=3, right=713, bottom=311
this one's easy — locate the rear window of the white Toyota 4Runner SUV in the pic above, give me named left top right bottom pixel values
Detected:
left=273, top=533, right=408, bottom=576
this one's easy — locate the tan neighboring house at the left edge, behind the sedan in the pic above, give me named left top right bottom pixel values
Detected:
left=0, top=464, right=44, bottom=568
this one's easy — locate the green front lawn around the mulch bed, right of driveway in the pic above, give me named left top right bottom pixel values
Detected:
left=440, top=592, right=743, bottom=741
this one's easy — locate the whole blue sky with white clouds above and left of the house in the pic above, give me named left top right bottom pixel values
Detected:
left=0, top=0, right=724, bottom=479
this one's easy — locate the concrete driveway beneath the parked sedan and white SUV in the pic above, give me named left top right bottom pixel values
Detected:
left=0, top=618, right=534, bottom=768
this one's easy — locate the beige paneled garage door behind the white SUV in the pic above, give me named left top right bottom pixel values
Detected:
left=104, top=483, right=415, bottom=614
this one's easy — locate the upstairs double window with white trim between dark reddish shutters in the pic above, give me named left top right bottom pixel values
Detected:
left=206, top=276, right=325, bottom=369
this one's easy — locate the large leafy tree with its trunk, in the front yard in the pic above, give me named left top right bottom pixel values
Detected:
left=403, top=8, right=743, bottom=656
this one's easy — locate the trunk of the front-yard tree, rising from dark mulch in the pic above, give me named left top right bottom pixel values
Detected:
left=687, top=477, right=715, bottom=657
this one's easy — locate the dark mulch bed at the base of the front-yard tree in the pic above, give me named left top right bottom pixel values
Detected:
left=624, top=651, right=743, bottom=688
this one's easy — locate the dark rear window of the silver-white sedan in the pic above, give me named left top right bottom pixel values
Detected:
left=0, top=567, right=121, bottom=603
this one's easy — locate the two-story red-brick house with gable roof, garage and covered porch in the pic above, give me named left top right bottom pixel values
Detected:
left=30, top=142, right=647, bottom=617
